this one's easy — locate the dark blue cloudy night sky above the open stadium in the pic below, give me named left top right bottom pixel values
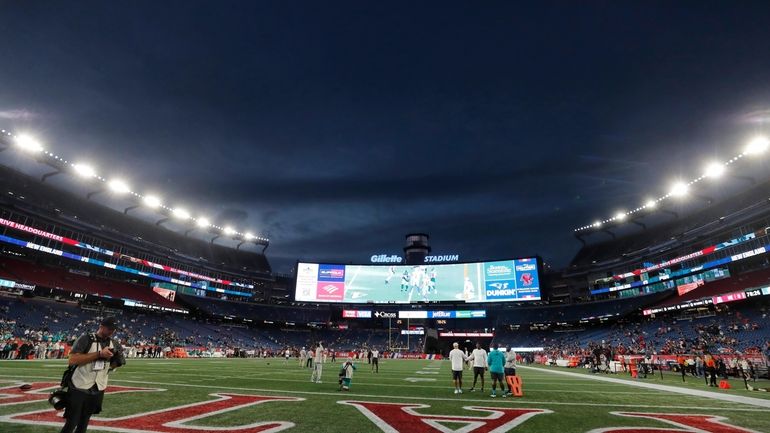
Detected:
left=0, top=0, right=770, bottom=271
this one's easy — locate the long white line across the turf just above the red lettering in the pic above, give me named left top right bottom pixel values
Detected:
left=0, top=374, right=770, bottom=413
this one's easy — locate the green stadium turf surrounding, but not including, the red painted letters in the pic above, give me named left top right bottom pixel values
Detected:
left=0, top=359, right=770, bottom=433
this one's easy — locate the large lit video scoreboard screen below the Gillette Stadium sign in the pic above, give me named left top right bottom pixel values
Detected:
left=294, top=258, right=540, bottom=304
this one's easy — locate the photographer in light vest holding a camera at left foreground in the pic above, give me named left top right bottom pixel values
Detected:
left=61, top=317, right=126, bottom=433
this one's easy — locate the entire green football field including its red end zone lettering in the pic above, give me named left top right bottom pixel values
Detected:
left=0, top=359, right=770, bottom=433
